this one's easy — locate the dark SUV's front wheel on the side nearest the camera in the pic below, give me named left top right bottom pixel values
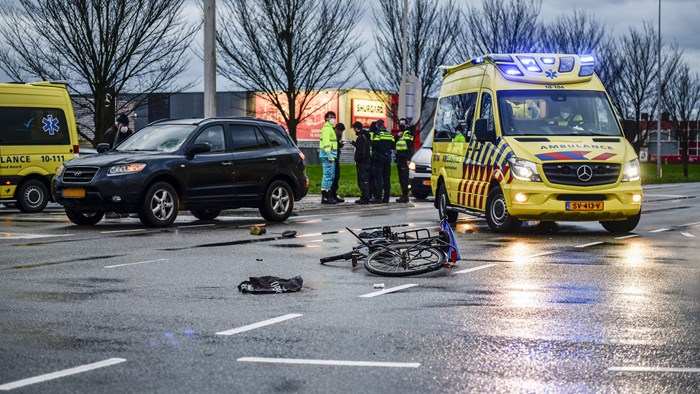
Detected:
left=139, top=182, right=180, bottom=227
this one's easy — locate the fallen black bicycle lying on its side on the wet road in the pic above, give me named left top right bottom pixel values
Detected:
left=320, top=226, right=450, bottom=277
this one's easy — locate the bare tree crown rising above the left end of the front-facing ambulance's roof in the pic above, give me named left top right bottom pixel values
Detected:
left=457, top=0, right=542, bottom=57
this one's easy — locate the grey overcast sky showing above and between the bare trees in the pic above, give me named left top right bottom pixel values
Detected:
left=0, top=0, right=700, bottom=91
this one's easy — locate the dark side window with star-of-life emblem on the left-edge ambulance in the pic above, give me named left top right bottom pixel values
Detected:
left=0, top=107, right=70, bottom=145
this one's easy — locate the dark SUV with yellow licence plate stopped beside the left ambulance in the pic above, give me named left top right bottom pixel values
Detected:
left=51, top=117, right=309, bottom=227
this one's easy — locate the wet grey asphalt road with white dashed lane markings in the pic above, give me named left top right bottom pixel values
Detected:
left=0, top=184, right=700, bottom=393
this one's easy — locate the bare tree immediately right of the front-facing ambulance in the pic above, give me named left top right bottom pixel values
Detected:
left=617, top=22, right=681, bottom=152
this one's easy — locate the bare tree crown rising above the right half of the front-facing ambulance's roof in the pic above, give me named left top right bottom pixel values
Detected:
left=539, top=10, right=606, bottom=54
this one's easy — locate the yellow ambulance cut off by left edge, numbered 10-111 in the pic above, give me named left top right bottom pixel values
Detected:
left=0, top=82, right=79, bottom=212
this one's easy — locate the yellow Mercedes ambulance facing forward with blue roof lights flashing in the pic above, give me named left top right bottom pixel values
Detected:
left=431, top=53, right=642, bottom=233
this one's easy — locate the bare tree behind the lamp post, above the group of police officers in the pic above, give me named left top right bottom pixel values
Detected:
left=361, top=0, right=462, bottom=127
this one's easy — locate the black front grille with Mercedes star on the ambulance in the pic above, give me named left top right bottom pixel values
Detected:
left=542, top=163, right=620, bottom=186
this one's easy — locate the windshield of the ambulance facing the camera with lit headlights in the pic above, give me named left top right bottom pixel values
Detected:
left=498, top=90, right=622, bottom=137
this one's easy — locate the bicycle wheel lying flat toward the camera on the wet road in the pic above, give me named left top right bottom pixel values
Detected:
left=365, top=243, right=446, bottom=276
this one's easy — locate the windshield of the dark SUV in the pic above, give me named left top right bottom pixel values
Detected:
left=115, top=124, right=196, bottom=152
